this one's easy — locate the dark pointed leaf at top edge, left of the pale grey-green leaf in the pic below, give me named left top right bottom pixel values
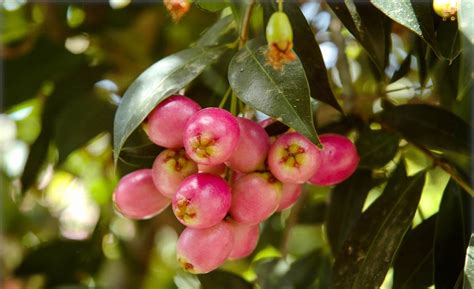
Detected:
left=327, top=0, right=391, bottom=75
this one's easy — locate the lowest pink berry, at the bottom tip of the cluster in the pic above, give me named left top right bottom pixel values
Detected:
left=176, top=222, right=234, bottom=274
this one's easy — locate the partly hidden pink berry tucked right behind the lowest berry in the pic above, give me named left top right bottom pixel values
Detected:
left=228, top=220, right=260, bottom=260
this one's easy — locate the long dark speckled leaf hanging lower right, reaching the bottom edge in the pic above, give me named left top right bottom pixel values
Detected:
left=331, top=163, right=424, bottom=289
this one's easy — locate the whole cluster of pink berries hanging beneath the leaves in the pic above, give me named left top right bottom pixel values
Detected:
left=114, top=95, right=359, bottom=273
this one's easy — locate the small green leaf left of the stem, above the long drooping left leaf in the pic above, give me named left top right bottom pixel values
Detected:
left=196, top=15, right=237, bottom=46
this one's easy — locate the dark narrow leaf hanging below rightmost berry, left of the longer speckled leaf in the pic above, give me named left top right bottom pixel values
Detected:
left=326, top=170, right=380, bottom=256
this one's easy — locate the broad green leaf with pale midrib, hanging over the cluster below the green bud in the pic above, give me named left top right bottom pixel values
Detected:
left=228, top=41, right=319, bottom=144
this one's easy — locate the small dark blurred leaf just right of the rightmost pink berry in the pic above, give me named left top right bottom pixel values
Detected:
left=356, top=127, right=400, bottom=169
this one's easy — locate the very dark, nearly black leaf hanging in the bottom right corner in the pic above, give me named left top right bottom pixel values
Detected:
left=434, top=180, right=472, bottom=289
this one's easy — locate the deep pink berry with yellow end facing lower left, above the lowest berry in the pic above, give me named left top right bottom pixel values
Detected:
left=173, top=173, right=232, bottom=228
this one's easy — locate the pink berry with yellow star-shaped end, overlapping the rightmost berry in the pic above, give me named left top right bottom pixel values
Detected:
left=268, top=132, right=321, bottom=184
